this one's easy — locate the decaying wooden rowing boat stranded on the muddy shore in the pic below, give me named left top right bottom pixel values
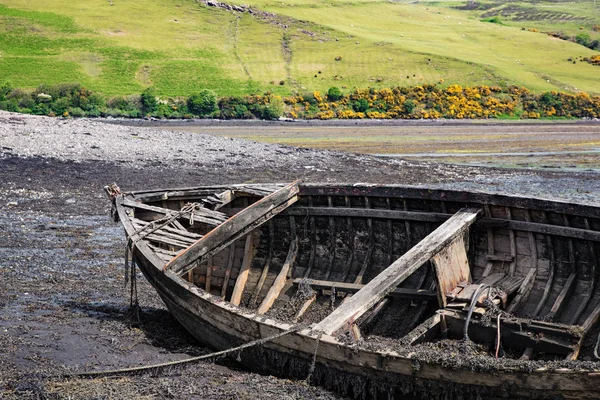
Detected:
left=107, top=182, right=600, bottom=399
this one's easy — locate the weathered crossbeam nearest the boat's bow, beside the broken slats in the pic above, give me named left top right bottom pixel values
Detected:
left=165, top=181, right=300, bottom=274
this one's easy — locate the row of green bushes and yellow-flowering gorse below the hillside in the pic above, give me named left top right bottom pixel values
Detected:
left=0, top=84, right=600, bottom=120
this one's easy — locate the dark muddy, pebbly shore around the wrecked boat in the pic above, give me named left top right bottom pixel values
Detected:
left=0, top=112, right=600, bottom=399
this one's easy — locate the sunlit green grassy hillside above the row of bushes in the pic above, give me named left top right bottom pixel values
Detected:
left=0, top=0, right=600, bottom=96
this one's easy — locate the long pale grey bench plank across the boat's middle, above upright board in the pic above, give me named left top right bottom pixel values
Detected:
left=315, top=209, right=480, bottom=334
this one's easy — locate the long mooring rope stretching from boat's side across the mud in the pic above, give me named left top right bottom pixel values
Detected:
left=61, top=324, right=304, bottom=378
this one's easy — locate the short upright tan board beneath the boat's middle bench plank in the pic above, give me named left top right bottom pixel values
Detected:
left=431, top=236, right=471, bottom=308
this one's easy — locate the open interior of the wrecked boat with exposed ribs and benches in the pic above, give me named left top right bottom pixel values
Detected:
left=116, top=183, right=600, bottom=361
